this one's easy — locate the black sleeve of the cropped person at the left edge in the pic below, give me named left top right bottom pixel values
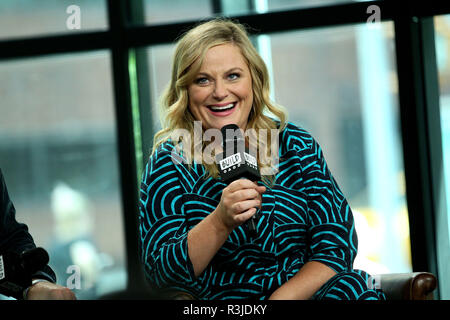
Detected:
left=0, top=169, right=56, bottom=282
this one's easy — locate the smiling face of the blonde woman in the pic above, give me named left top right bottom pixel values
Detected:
left=188, top=43, right=253, bottom=130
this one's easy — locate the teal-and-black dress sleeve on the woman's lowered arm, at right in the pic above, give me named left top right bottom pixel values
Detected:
left=304, top=135, right=358, bottom=272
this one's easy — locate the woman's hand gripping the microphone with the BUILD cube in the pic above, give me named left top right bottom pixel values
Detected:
left=214, top=179, right=266, bottom=231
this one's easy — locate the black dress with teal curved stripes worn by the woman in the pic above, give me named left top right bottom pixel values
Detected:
left=139, top=122, right=385, bottom=299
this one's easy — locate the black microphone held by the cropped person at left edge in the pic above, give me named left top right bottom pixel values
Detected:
left=0, top=248, right=49, bottom=300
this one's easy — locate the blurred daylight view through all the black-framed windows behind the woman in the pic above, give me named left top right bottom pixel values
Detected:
left=0, top=0, right=450, bottom=299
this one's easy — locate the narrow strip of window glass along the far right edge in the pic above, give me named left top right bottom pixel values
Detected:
left=435, top=15, right=450, bottom=300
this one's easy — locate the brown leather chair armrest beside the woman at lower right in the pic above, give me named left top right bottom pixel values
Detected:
left=378, top=272, right=437, bottom=300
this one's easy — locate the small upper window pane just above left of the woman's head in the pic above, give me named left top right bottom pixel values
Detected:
left=145, top=0, right=213, bottom=24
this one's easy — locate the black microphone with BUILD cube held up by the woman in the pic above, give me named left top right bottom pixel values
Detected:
left=216, top=124, right=261, bottom=237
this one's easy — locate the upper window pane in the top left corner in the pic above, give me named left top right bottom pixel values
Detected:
left=0, top=0, right=108, bottom=39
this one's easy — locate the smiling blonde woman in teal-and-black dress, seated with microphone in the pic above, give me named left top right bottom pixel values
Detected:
left=140, top=19, right=384, bottom=299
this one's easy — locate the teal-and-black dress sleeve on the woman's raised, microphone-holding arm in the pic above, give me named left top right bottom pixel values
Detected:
left=139, top=144, right=197, bottom=290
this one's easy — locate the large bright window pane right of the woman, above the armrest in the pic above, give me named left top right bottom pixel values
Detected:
left=268, top=23, right=411, bottom=273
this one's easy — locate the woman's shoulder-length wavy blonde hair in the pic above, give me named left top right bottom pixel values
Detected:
left=152, top=18, right=287, bottom=184
